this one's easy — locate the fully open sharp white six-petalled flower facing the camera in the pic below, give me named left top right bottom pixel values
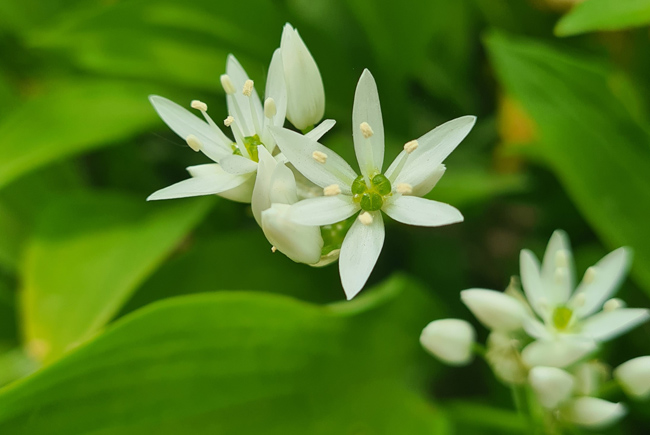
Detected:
left=271, top=70, right=476, bottom=299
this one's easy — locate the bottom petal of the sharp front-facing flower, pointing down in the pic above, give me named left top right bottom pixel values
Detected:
left=339, top=211, right=385, bottom=300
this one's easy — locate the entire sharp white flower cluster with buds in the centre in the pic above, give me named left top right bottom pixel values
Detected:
left=149, top=20, right=475, bottom=299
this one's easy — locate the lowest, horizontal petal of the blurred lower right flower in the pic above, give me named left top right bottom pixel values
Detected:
left=521, top=336, right=597, bottom=367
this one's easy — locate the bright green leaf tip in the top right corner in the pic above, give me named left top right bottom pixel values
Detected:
left=555, top=0, right=650, bottom=36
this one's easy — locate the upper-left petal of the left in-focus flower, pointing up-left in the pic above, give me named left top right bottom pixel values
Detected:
left=149, top=95, right=232, bottom=162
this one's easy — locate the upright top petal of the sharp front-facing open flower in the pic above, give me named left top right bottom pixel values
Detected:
left=352, top=69, right=384, bottom=177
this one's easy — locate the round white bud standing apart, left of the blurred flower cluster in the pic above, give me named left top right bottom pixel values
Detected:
left=420, top=319, right=476, bottom=366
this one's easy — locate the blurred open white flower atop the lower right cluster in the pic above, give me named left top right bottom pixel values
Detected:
left=461, top=231, right=650, bottom=367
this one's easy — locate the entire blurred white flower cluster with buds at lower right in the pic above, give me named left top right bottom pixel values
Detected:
left=420, top=231, right=650, bottom=428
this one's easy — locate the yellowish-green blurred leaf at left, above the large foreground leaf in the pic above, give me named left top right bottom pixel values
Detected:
left=21, top=192, right=212, bottom=362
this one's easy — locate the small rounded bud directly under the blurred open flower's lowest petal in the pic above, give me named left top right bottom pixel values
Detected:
left=528, top=367, right=575, bottom=409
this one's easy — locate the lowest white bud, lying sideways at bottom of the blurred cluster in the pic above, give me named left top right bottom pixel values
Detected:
left=559, top=396, right=626, bottom=429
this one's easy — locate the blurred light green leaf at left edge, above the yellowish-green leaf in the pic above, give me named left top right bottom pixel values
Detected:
left=0, top=80, right=157, bottom=187
